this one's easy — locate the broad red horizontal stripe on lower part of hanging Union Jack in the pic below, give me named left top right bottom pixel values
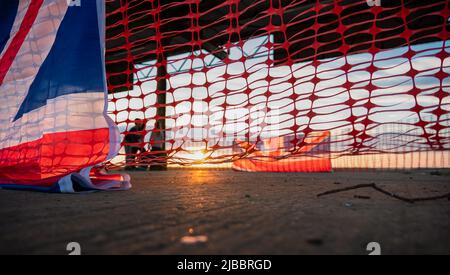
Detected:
left=0, top=128, right=109, bottom=186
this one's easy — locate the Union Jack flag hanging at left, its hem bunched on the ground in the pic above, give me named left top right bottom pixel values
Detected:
left=0, top=0, right=130, bottom=193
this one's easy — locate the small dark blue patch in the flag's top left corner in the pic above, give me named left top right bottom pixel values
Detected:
left=0, top=0, right=19, bottom=53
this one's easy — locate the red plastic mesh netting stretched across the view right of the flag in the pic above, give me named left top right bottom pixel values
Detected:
left=106, top=0, right=450, bottom=169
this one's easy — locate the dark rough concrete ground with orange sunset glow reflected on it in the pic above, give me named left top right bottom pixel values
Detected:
left=0, top=170, right=450, bottom=254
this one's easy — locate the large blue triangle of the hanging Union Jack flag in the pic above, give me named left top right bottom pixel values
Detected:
left=14, top=1, right=105, bottom=120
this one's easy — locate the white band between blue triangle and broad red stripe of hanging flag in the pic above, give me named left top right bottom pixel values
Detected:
left=0, top=92, right=109, bottom=149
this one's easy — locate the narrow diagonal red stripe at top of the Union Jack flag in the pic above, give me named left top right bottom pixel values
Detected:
left=0, top=0, right=44, bottom=85
